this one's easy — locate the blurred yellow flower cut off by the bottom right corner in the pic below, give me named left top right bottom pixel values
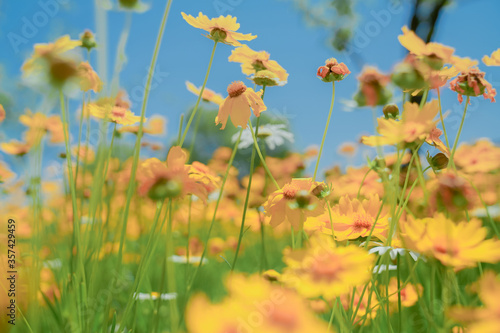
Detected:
left=448, top=271, right=500, bottom=333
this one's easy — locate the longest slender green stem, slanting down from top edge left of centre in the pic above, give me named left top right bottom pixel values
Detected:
left=118, top=0, right=172, bottom=271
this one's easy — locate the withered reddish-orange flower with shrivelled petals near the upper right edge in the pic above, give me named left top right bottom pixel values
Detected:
left=450, top=68, right=497, bottom=103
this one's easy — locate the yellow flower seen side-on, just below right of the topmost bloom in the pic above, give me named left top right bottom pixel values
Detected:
left=228, top=45, right=288, bottom=83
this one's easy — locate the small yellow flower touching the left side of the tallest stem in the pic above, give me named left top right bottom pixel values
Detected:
left=87, top=92, right=141, bottom=125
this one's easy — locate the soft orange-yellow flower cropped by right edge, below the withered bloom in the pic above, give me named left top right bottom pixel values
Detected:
left=454, top=139, right=500, bottom=173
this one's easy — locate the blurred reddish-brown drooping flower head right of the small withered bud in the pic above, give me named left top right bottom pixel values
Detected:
left=354, top=67, right=392, bottom=107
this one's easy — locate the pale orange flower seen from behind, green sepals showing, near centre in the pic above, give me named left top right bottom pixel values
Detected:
left=263, top=178, right=326, bottom=230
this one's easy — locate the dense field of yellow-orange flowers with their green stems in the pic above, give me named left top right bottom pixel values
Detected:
left=0, top=7, right=500, bottom=333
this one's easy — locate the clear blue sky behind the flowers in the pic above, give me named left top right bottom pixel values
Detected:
left=0, top=0, right=500, bottom=178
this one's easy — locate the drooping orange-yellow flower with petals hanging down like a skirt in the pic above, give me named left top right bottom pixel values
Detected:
left=215, top=81, right=267, bottom=130
